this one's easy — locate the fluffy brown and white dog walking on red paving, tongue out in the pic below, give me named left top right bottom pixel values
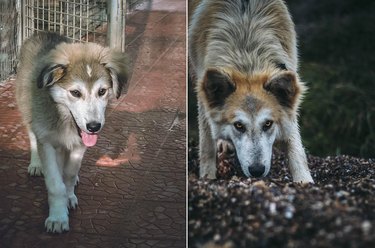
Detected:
left=16, top=33, right=128, bottom=233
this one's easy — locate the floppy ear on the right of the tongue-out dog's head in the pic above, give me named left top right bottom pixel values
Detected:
left=102, top=49, right=128, bottom=99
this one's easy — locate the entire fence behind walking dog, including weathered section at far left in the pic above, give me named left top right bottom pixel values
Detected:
left=0, top=0, right=143, bottom=81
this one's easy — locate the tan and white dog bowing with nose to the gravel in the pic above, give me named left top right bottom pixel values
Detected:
left=188, top=0, right=313, bottom=183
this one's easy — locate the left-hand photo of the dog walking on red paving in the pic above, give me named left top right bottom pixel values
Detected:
left=0, top=0, right=187, bottom=248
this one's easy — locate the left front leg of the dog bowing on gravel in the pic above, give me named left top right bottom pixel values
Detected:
left=198, top=105, right=216, bottom=179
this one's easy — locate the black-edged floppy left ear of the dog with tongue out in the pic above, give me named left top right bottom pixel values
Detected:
left=37, top=64, right=66, bottom=89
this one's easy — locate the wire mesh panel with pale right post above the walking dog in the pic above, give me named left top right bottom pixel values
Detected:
left=21, top=0, right=126, bottom=51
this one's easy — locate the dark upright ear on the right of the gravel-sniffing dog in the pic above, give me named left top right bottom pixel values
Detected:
left=264, top=71, right=301, bottom=108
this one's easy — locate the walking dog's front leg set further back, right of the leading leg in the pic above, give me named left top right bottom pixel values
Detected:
left=64, top=146, right=86, bottom=209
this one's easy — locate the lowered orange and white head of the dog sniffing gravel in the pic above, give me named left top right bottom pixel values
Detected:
left=198, top=69, right=303, bottom=177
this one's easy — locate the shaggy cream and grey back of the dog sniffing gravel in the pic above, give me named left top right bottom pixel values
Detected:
left=189, top=0, right=297, bottom=78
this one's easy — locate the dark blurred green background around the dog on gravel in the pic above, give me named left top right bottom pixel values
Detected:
left=188, top=0, right=375, bottom=158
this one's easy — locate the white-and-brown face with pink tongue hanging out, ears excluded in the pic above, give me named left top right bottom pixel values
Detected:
left=50, top=63, right=113, bottom=146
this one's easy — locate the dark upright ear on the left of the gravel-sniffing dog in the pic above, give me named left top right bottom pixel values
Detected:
left=202, top=69, right=236, bottom=107
